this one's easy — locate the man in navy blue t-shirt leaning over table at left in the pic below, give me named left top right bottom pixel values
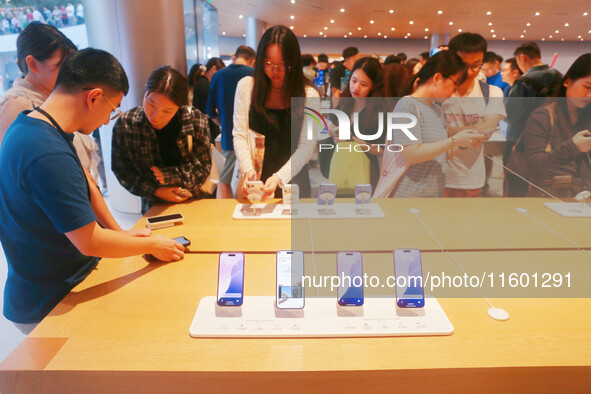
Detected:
left=0, top=48, right=184, bottom=334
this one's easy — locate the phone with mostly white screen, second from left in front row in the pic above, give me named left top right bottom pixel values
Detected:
left=275, top=250, right=305, bottom=309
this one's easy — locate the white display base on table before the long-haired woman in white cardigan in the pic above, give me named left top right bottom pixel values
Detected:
left=232, top=203, right=384, bottom=219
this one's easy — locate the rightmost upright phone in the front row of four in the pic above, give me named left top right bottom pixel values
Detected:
left=394, top=249, right=425, bottom=308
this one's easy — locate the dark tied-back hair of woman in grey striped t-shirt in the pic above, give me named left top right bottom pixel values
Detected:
left=405, top=51, right=467, bottom=95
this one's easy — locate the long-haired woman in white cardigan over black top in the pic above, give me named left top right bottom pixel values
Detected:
left=232, top=26, right=320, bottom=197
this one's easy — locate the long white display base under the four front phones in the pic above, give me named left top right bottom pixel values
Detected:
left=189, top=296, right=454, bottom=338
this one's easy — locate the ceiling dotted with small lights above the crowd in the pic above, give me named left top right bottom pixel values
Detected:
left=210, top=0, right=591, bottom=41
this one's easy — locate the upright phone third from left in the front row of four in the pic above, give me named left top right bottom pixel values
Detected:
left=337, top=252, right=363, bottom=306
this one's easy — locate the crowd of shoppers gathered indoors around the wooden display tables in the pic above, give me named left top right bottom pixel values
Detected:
left=0, top=22, right=591, bottom=332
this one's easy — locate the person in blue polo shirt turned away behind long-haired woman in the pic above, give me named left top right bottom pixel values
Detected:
left=207, top=45, right=256, bottom=198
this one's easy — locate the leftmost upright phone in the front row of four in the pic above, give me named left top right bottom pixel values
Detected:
left=218, top=253, right=244, bottom=306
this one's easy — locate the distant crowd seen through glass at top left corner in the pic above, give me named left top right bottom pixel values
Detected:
left=0, top=3, right=84, bottom=34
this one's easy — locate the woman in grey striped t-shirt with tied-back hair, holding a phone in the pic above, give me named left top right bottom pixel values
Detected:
left=384, top=51, right=481, bottom=198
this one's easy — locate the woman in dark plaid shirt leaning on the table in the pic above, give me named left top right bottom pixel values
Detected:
left=111, top=66, right=211, bottom=213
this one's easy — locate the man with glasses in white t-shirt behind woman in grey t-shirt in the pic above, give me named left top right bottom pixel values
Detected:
left=442, top=33, right=507, bottom=197
